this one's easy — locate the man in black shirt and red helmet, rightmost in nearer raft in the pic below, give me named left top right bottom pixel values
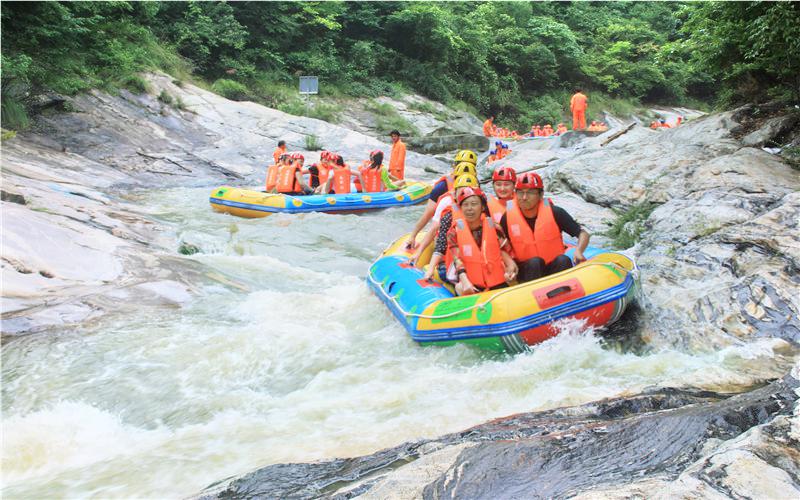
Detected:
left=500, top=172, right=589, bottom=283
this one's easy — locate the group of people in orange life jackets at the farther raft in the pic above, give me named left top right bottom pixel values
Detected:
left=265, top=130, right=406, bottom=195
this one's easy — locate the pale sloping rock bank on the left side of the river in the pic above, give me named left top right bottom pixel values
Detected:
left=2, top=74, right=446, bottom=336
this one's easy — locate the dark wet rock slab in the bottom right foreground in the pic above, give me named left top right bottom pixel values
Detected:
left=198, top=375, right=800, bottom=499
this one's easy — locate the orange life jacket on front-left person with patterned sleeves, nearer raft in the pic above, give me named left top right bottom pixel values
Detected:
left=453, top=207, right=506, bottom=289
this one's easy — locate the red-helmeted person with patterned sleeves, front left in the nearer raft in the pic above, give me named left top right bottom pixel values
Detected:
left=447, top=187, right=517, bottom=295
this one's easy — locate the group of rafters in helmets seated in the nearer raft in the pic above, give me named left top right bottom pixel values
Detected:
left=406, top=150, right=590, bottom=295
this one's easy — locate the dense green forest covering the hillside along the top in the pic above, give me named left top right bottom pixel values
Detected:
left=2, top=2, right=800, bottom=128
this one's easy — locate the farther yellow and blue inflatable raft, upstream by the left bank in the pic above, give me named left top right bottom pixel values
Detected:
left=209, top=181, right=431, bottom=218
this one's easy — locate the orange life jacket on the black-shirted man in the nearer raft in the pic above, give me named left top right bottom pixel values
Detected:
left=506, top=199, right=566, bottom=264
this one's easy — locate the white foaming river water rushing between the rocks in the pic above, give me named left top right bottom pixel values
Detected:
left=0, top=188, right=795, bottom=498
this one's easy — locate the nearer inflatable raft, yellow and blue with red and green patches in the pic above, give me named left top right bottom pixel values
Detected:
left=367, top=235, right=639, bottom=352
